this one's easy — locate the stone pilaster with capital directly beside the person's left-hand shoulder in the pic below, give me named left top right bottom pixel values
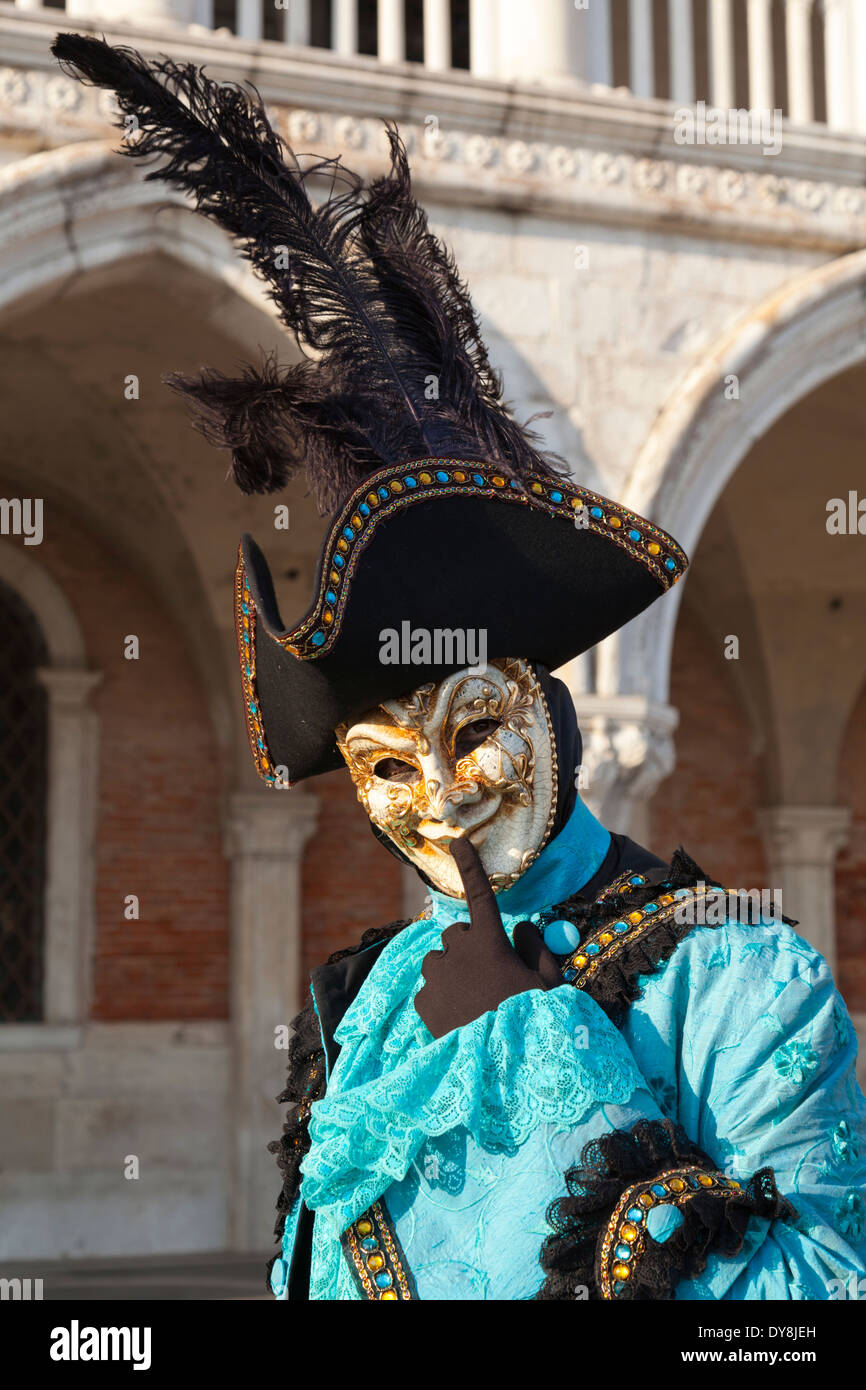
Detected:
left=225, top=790, right=318, bottom=1251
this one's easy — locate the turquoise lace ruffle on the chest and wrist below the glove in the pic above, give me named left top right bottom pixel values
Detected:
left=302, top=920, right=642, bottom=1236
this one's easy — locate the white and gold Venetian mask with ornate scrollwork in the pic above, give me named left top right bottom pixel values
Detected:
left=336, top=659, right=557, bottom=898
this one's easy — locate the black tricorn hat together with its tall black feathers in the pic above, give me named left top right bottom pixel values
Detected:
left=53, top=33, right=687, bottom=784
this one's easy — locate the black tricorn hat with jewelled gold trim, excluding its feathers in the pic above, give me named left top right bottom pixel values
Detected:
left=235, top=459, right=687, bottom=785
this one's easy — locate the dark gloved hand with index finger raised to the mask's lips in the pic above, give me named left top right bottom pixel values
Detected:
left=416, top=838, right=563, bottom=1038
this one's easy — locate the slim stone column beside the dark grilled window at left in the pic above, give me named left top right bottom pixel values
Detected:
left=36, top=667, right=102, bottom=1023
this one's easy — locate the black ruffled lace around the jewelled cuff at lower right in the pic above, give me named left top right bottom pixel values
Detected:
left=535, top=1120, right=795, bottom=1301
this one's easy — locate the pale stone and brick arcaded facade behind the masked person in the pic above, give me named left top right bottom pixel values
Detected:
left=0, top=7, right=866, bottom=1258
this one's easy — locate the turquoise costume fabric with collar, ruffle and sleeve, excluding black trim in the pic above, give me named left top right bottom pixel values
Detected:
left=271, top=801, right=866, bottom=1300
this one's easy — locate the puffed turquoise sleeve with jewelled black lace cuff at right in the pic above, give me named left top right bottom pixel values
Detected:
left=595, top=923, right=866, bottom=1300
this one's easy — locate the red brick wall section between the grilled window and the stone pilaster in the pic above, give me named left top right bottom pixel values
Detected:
left=22, top=503, right=229, bottom=1020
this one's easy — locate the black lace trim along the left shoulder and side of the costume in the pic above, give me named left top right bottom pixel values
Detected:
left=267, top=922, right=409, bottom=1291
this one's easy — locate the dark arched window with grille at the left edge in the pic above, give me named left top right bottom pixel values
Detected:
left=0, top=584, right=47, bottom=1023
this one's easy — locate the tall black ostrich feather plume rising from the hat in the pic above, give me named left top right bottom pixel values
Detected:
left=51, top=33, right=563, bottom=510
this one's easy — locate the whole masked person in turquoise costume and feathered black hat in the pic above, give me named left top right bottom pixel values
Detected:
left=54, top=35, right=866, bottom=1302
